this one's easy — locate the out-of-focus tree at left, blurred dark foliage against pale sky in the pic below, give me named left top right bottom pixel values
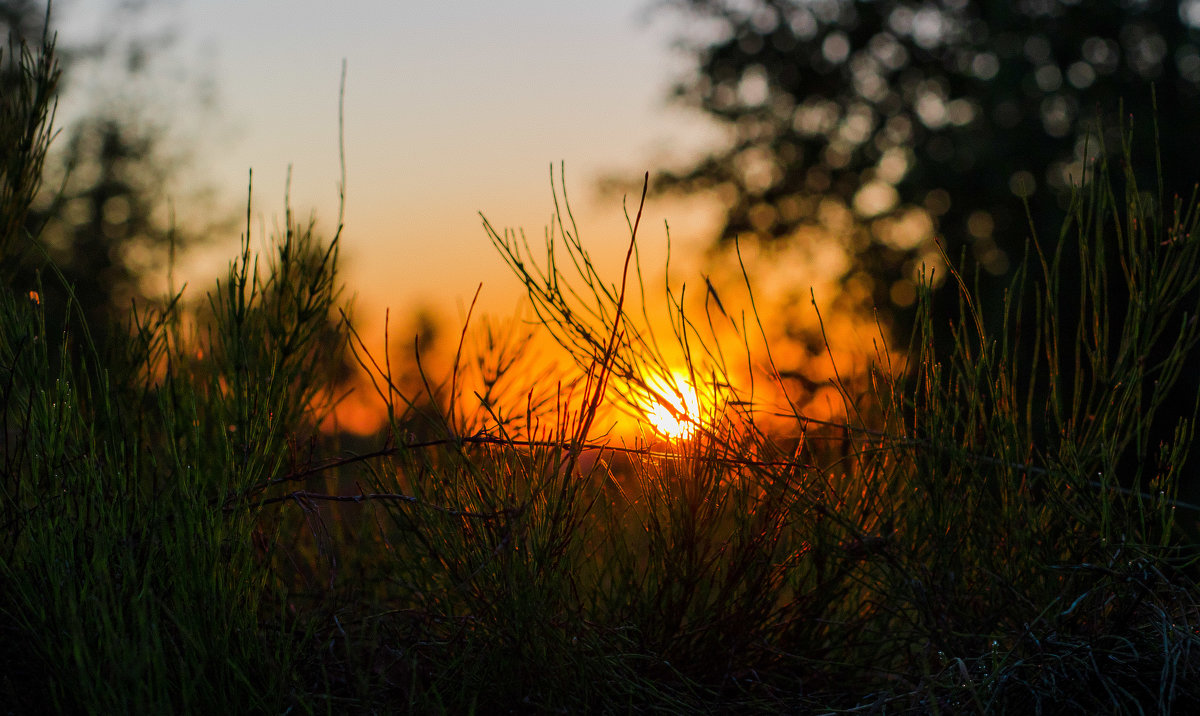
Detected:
left=0, top=0, right=218, bottom=347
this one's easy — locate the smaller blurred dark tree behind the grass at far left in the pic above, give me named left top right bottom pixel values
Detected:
left=0, top=0, right=208, bottom=342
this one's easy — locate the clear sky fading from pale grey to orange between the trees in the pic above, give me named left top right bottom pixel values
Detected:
left=55, top=0, right=720, bottom=319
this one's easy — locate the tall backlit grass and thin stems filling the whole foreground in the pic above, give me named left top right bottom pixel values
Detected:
left=0, top=32, right=1200, bottom=714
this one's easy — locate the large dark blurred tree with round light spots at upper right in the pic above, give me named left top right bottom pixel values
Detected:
left=658, top=0, right=1200, bottom=326
